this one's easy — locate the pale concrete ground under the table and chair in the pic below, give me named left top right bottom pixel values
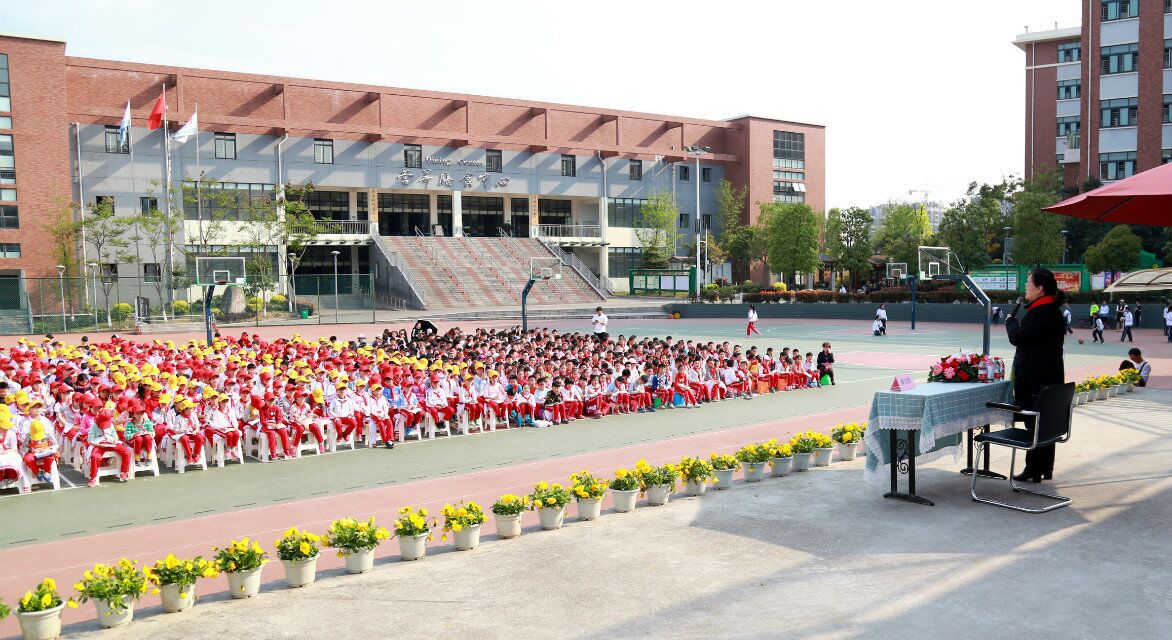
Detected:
left=67, top=390, right=1172, bottom=640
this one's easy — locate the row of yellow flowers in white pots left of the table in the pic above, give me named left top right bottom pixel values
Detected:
left=0, top=423, right=866, bottom=640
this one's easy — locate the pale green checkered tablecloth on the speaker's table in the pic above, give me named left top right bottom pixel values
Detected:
left=863, top=381, right=1013, bottom=482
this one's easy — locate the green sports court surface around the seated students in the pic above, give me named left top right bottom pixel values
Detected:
left=0, top=320, right=1125, bottom=549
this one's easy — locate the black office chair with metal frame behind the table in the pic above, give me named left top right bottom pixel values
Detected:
left=970, top=382, right=1075, bottom=513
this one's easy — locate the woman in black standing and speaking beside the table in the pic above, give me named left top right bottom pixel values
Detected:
left=1006, top=267, right=1067, bottom=482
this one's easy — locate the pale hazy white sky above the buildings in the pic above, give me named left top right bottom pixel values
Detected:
left=0, top=0, right=1081, bottom=206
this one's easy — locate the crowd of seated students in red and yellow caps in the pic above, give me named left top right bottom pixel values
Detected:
left=0, top=328, right=833, bottom=492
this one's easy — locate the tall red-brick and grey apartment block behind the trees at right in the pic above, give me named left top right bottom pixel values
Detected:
left=1014, top=0, right=1172, bottom=192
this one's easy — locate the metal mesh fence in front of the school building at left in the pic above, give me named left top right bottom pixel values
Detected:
left=0, top=273, right=382, bottom=335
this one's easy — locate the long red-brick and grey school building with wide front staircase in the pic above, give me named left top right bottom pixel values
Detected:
left=0, top=34, right=825, bottom=306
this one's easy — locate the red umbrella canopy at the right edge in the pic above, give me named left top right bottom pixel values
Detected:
left=1045, top=164, right=1172, bottom=226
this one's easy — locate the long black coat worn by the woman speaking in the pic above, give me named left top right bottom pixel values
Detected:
left=1006, top=302, right=1067, bottom=409
